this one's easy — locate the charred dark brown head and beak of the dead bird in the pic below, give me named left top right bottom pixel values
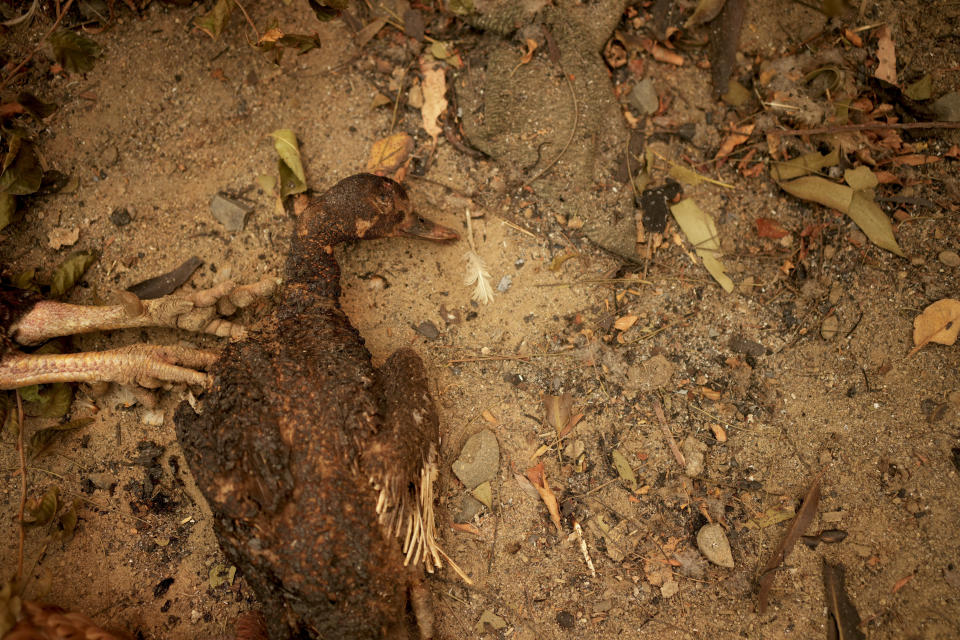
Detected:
left=323, top=173, right=460, bottom=242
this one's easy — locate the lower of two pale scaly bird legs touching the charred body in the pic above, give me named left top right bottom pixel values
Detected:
left=0, top=344, right=218, bottom=389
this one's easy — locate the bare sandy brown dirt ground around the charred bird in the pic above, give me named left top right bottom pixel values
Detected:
left=0, top=0, right=960, bottom=639
